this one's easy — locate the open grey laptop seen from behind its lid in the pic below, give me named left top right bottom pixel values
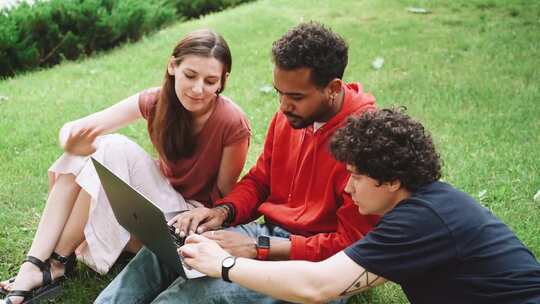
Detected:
left=91, top=157, right=205, bottom=279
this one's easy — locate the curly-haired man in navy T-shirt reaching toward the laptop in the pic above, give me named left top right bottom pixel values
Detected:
left=181, top=109, right=540, bottom=304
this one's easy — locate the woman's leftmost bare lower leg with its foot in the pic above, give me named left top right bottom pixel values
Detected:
left=0, top=174, right=81, bottom=304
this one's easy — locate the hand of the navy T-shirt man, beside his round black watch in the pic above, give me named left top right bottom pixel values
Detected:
left=178, top=234, right=229, bottom=278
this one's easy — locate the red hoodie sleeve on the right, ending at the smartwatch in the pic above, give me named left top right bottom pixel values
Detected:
left=289, top=185, right=379, bottom=261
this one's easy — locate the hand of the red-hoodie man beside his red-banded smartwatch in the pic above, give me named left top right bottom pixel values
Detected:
left=203, top=230, right=257, bottom=259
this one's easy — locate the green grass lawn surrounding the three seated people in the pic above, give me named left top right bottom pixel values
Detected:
left=0, top=0, right=540, bottom=303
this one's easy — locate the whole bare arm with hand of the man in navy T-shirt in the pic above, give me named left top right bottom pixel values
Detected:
left=184, top=235, right=385, bottom=302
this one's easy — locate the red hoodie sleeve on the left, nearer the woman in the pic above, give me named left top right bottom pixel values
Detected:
left=216, top=116, right=276, bottom=225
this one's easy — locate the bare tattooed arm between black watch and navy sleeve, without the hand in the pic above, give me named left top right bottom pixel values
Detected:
left=229, top=252, right=386, bottom=303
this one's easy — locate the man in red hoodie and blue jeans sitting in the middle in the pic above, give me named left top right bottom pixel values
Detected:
left=96, top=22, right=378, bottom=303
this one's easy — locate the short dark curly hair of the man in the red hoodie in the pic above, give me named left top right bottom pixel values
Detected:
left=272, top=21, right=348, bottom=88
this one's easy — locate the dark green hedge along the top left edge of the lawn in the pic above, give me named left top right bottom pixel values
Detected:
left=0, top=0, right=252, bottom=77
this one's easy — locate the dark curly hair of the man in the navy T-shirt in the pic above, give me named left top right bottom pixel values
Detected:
left=330, top=108, right=441, bottom=191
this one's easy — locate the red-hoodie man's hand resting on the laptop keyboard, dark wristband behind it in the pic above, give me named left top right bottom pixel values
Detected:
left=167, top=207, right=227, bottom=237
